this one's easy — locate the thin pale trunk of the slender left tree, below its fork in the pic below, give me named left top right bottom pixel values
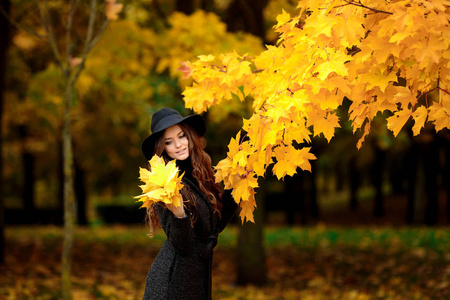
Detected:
left=61, top=82, right=75, bottom=300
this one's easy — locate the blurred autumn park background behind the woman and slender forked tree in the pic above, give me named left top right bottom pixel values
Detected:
left=0, top=0, right=450, bottom=299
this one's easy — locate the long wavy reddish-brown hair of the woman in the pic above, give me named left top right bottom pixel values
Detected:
left=146, top=122, right=222, bottom=236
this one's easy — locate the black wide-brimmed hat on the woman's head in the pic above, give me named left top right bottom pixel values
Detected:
left=142, top=107, right=206, bottom=160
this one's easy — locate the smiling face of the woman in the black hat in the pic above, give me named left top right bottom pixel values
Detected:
left=162, top=125, right=189, bottom=160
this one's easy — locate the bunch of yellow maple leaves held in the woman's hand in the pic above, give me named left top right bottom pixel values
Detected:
left=134, top=155, right=184, bottom=208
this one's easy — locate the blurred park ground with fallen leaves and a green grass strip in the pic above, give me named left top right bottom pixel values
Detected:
left=0, top=225, right=450, bottom=300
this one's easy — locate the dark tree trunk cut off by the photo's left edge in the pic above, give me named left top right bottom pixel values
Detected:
left=0, top=0, right=10, bottom=264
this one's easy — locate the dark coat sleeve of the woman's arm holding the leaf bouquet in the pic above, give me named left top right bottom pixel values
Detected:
left=156, top=205, right=194, bottom=256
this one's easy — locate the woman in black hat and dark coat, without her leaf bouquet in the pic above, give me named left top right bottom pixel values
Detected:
left=142, top=108, right=237, bottom=300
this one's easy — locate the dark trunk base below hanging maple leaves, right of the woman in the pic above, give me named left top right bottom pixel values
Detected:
left=237, top=191, right=267, bottom=286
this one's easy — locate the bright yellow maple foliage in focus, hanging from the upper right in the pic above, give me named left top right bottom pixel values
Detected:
left=183, top=0, right=450, bottom=221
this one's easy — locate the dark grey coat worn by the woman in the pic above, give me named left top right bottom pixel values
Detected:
left=143, top=178, right=238, bottom=300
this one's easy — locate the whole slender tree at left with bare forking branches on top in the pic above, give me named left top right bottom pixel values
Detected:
left=28, top=0, right=122, bottom=299
